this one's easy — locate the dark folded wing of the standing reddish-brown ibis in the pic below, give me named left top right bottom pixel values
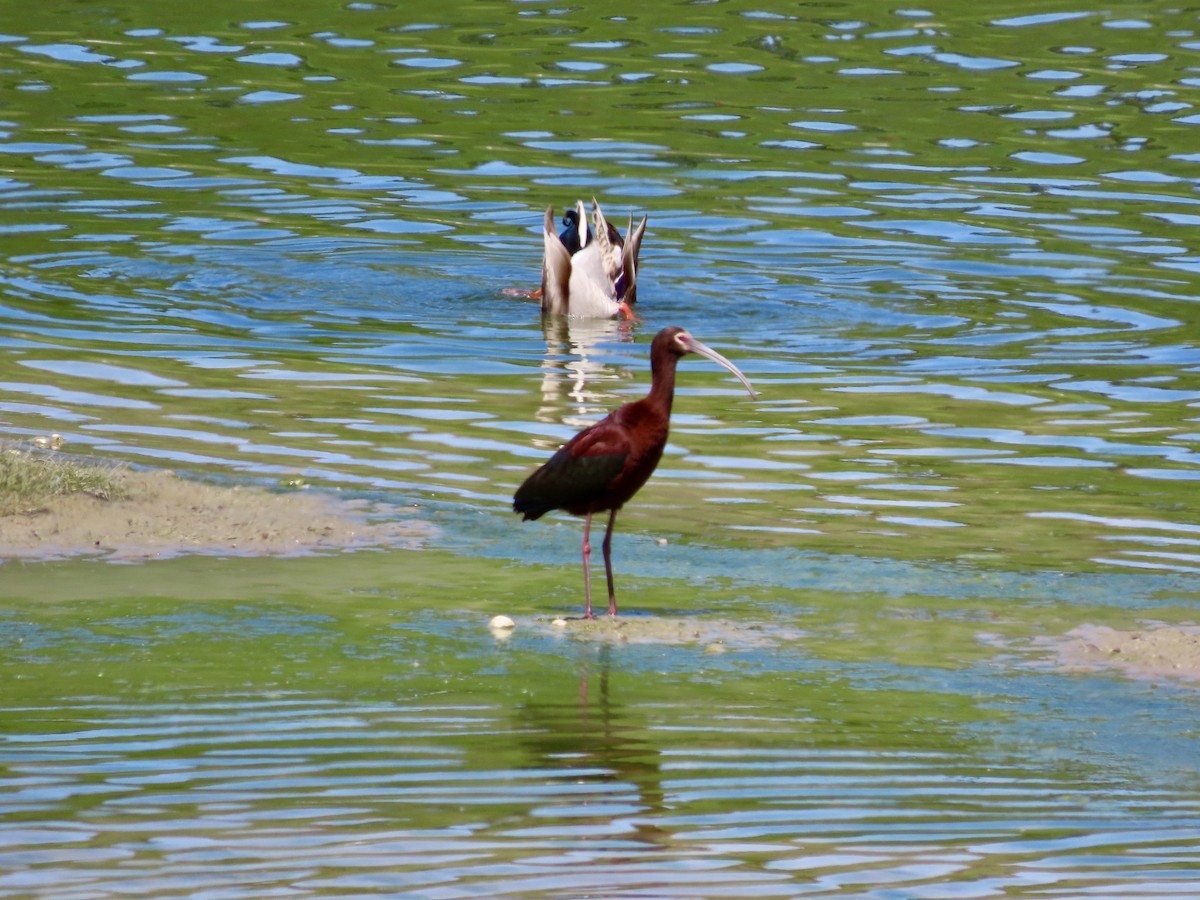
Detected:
left=512, top=422, right=629, bottom=518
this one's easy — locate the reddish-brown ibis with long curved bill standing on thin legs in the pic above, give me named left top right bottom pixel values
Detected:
left=512, top=326, right=754, bottom=618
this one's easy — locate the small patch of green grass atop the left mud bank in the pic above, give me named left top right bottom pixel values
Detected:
left=0, top=442, right=124, bottom=516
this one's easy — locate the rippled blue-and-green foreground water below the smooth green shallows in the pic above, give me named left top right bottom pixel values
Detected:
left=0, top=700, right=1200, bottom=898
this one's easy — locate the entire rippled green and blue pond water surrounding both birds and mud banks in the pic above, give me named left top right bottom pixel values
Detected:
left=0, top=2, right=1200, bottom=898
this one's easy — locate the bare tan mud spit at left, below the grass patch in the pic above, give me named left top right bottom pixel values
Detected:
left=0, top=469, right=432, bottom=560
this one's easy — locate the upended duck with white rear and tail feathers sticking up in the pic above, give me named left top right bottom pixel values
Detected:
left=541, top=197, right=646, bottom=318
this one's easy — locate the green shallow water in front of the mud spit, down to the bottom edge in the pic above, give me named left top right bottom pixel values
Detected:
left=7, top=551, right=1200, bottom=898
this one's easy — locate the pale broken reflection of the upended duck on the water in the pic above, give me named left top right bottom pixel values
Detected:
left=535, top=314, right=634, bottom=434
